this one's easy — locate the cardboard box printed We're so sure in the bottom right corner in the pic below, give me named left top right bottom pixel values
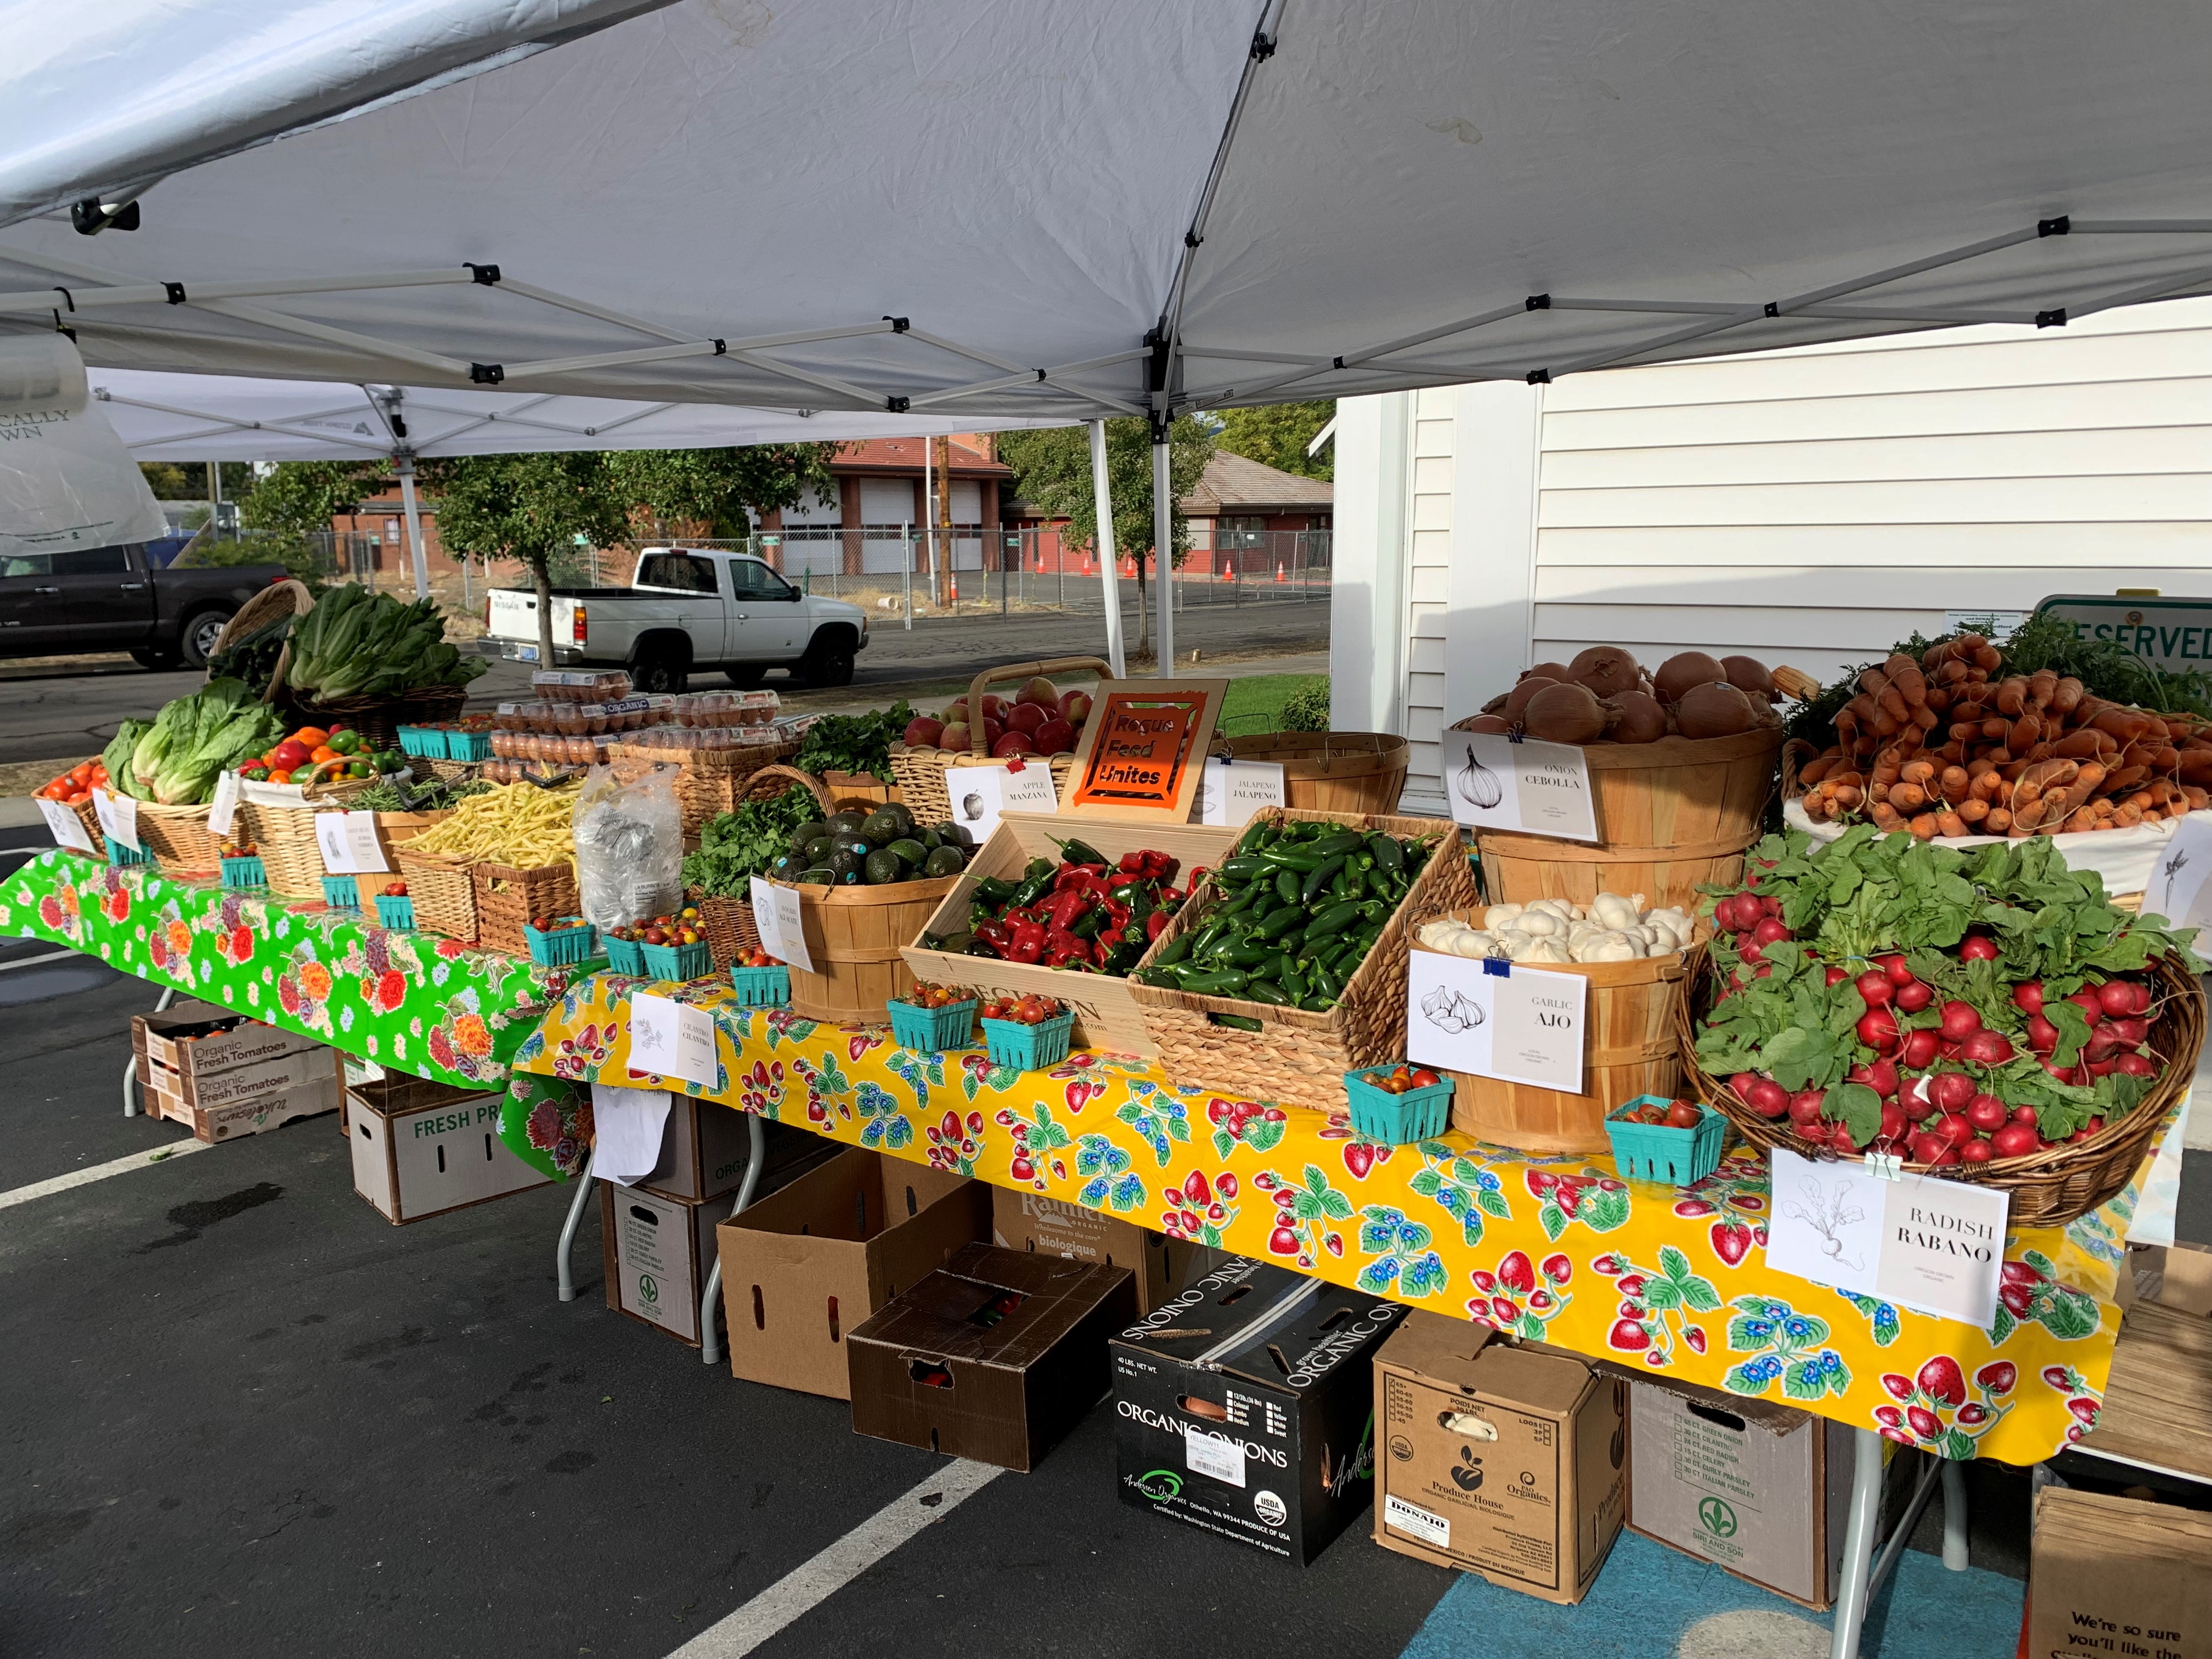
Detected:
left=2024, top=1487, right=2212, bottom=1659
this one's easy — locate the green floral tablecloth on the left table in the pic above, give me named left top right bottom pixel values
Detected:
left=0, top=849, right=566, bottom=1088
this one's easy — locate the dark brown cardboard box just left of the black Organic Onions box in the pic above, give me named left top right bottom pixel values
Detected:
left=845, top=1243, right=1137, bottom=1473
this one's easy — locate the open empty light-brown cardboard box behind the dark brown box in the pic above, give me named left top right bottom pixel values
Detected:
left=714, top=1146, right=991, bottom=1400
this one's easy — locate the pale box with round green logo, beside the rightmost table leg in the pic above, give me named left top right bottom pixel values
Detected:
left=1628, top=1367, right=1852, bottom=1612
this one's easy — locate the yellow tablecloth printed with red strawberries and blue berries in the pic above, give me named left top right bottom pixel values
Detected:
left=513, top=973, right=2132, bottom=1462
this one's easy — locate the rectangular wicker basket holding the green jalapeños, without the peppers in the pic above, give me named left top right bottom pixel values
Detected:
left=1128, top=808, right=1477, bottom=1110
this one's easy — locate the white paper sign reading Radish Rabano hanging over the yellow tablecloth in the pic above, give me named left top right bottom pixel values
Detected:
left=1768, top=1148, right=2011, bottom=1329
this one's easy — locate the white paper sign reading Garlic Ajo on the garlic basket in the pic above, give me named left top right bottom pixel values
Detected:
left=1404, top=951, right=1590, bottom=1095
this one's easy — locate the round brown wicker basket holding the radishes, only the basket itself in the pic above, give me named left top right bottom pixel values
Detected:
left=1677, top=956, right=2205, bottom=1228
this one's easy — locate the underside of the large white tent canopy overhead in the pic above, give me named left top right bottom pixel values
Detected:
left=0, top=0, right=2212, bottom=425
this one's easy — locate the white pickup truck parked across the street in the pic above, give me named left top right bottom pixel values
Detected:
left=480, top=546, right=867, bottom=692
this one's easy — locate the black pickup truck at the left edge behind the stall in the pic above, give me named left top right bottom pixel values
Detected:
left=0, top=542, right=285, bottom=668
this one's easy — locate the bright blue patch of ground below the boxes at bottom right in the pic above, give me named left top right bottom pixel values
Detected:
left=1402, top=1533, right=2026, bottom=1659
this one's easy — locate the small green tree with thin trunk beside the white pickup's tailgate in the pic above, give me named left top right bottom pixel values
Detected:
left=420, top=449, right=630, bottom=668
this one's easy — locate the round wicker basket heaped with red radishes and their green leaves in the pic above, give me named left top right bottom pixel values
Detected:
left=1683, top=825, right=2205, bottom=1226
